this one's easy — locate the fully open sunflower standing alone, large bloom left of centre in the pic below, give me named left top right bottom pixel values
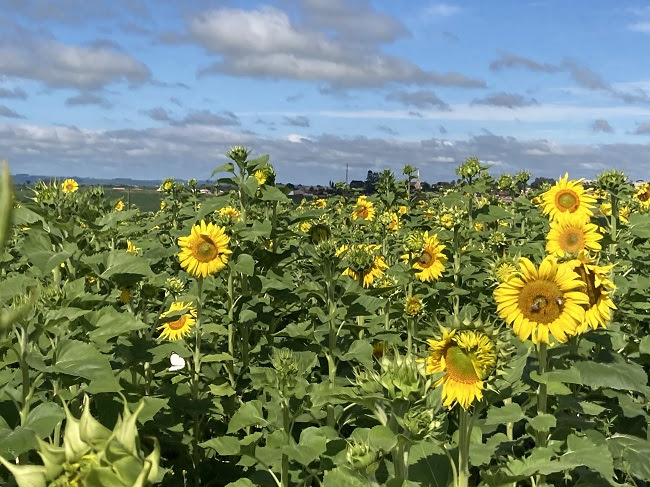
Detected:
left=178, top=220, right=232, bottom=277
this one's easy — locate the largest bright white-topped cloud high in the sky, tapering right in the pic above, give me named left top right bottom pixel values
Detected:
left=189, top=2, right=485, bottom=87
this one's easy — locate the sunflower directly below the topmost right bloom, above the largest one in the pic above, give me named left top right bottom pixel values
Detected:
left=546, top=214, right=603, bottom=257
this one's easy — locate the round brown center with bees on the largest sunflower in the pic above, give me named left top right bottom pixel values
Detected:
left=519, top=279, right=564, bottom=324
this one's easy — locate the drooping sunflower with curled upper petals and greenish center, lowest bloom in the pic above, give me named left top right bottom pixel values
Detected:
left=426, top=330, right=497, bottom=409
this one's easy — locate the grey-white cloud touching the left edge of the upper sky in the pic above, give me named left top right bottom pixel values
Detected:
left=0, top=39, right=151, bottom=89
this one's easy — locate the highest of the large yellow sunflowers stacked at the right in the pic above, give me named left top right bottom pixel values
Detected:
left=542, top=173, right=596, bottom=221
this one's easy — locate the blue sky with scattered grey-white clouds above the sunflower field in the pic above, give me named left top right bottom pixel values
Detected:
left=0, top=0, right=650, bottom=184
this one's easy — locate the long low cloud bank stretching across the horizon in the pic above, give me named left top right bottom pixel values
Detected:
left=5, top=123, right=650, bottom=184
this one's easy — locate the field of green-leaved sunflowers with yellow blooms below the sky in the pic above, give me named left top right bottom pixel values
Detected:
left=0, top=151, right=650, bottom=487
